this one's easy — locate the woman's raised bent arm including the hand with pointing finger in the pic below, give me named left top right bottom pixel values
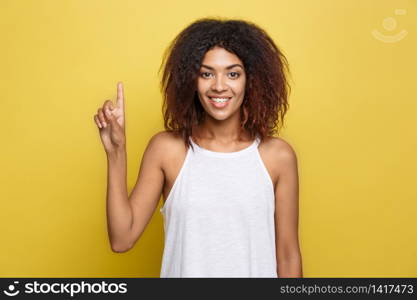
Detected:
left=94, top=83, right=164, bottom=252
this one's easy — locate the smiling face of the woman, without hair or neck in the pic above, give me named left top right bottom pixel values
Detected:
left=197, top=47, right=246, bottom=120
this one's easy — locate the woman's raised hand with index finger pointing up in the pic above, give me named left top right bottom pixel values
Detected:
left=94, top=82, right=126, bottom=154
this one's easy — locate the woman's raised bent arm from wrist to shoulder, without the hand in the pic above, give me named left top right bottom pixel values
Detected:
left=107, top=133, right=164, bottom=252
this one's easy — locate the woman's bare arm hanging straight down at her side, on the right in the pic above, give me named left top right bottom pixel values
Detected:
left=275, top=140, right=303, bottom=277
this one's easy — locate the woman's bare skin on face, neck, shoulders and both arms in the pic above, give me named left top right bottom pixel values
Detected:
left=94, top=47, right=303, bottom=277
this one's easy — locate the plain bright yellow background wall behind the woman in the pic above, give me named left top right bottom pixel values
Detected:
left=0, top=0, right=417, bottom=277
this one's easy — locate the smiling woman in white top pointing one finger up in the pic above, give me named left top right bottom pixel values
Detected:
left=94, top=18, right=302, bottom=277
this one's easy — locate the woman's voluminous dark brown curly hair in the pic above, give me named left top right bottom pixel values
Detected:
left=158, top=18, right=290, bottom=148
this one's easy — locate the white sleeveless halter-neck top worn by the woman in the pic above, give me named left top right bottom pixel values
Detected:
left=160, top=137, right=278, bottom=277
